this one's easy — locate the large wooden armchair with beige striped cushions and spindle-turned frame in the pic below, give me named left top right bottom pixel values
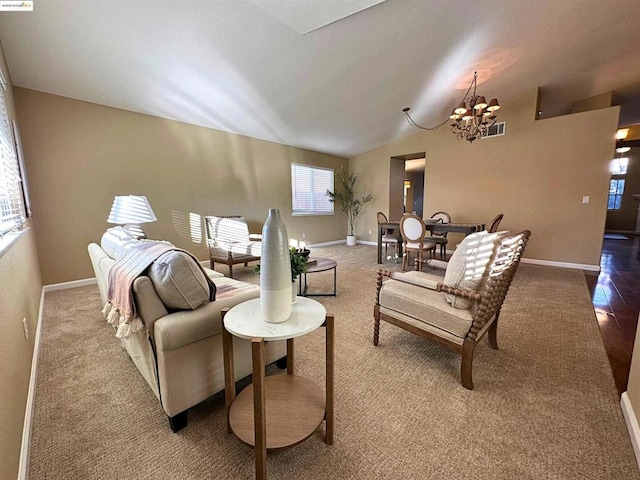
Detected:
left=373, top=230, right=531, bottom=390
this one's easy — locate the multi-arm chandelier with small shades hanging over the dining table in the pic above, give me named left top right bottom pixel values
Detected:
left=402, top=72, right=500, bottom=142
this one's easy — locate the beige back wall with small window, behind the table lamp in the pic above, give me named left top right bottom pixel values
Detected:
left=15, top=88, right=347, bottom=284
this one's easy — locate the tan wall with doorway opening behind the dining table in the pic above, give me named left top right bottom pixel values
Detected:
left=349, top=90, right=619, bottom=268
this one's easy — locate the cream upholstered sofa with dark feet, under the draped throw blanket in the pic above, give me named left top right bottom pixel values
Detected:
left=88, top=227, right=286, bottom=432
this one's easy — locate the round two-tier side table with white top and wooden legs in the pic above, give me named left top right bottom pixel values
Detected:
left=222, top=297, right=334, bottom=479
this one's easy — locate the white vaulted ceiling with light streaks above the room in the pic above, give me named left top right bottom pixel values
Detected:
left=0, top=0, right=640, bottom=157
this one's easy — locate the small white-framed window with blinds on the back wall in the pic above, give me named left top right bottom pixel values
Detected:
left=291, top=163, right=333, bottom=215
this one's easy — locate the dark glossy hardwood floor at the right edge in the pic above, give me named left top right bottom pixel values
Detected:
left=585, top=235, right=640, bottom=394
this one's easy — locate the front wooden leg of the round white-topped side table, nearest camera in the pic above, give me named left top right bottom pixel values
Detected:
left=251, top=338, right=267, bottom=480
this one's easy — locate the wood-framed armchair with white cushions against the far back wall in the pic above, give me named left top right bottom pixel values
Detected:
left=204, top=215, right=262, bottom=278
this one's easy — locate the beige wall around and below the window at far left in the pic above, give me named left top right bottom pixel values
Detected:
left=0, top=50, right=42, bottom=479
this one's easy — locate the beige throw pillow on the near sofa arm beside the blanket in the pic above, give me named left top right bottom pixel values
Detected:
left=147, top=250, right=209, bottom=310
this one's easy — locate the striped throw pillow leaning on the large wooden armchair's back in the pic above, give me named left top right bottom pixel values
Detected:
left=444, top=230, right=504, bottom=308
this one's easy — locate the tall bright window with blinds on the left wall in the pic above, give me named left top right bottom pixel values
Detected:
left=0, top=75, right=25, bottom=236
